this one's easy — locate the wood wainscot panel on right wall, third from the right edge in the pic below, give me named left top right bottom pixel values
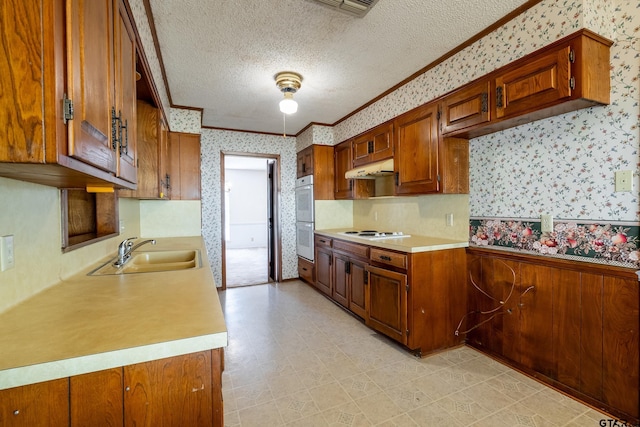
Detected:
left=551, top=269, right=581, bottom=390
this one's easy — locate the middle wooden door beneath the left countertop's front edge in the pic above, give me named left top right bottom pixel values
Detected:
left=69, top=368, right=124, bottom=427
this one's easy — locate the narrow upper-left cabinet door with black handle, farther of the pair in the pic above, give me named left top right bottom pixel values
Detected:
left=113, top=0, right=137, bottom=183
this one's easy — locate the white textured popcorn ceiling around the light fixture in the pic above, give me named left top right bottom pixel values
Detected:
left=150, top=0, right=526, bottom=134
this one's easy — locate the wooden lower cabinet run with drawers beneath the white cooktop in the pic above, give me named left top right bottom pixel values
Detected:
left=315, top=236, right=466, bottom=355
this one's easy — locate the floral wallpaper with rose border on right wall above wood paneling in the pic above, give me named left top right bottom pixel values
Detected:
left=470, top=0, right=640, bottom=268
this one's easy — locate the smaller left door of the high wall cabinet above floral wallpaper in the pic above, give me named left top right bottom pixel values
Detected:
left=442, top=80, right=491, bottom=135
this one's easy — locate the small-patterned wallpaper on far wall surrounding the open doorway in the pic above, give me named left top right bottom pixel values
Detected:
left=200, top=129, right=298, bottom=283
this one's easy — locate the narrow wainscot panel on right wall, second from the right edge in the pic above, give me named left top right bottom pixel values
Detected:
left=579, top=273, right=604, bottom=400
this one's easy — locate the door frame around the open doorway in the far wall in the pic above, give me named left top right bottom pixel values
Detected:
left=220, top=150, right=282, bottom=290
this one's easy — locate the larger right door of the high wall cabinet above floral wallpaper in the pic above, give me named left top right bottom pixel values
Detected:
left=495, top=46, right=571, bottom=119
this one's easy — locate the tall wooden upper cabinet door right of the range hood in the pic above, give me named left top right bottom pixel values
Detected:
left=394, top=103, right=439, bottom=195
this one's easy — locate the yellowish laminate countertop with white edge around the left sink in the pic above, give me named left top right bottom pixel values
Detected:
left=0, top=237, right=227, bottom=390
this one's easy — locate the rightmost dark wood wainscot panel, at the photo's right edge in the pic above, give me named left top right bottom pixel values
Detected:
left=603, top=277, right=640, bottom=419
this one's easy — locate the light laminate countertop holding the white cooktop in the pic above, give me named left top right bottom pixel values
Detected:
left=315, top=228, right=469, bottom=253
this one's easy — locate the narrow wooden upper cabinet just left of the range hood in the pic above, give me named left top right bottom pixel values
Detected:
left=333, top=140, right=374, bottom=200
